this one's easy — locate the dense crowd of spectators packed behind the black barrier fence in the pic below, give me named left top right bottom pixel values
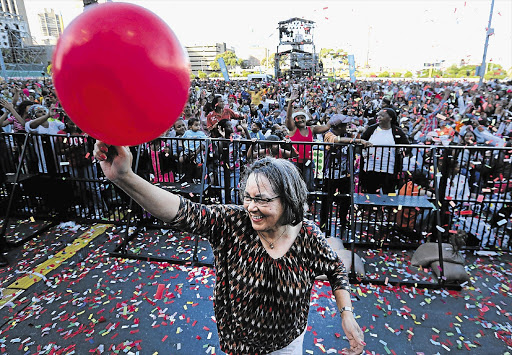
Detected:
left=0, top=78, right=512, bottom=242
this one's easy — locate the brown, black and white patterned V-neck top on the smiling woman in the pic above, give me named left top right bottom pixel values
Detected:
left=171, top=198, right=350, bottom=354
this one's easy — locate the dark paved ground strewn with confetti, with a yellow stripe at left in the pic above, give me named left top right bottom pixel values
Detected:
left=0, top=221, right=512, bottom=355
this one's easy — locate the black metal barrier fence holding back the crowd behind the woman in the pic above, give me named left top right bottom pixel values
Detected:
left=0, top=133, right=512, bottom=286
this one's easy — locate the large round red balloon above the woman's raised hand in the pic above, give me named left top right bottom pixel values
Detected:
left=52, top=3, right=190, bottom=145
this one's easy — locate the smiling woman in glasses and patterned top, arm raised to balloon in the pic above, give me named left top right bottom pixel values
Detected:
left=94, top=142, right=366, bottom=354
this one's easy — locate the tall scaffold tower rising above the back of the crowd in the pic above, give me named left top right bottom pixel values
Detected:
left=274, top=17, right=318, bottom=78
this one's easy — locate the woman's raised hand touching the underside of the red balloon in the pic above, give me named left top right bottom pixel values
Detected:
left=93, top=141, right=133, bottom=183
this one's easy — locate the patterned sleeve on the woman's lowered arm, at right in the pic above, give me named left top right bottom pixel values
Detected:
left=306, top=222, right=350, bottom=292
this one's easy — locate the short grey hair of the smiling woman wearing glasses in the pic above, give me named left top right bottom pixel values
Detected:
left=240, top=157, right=308, bottom=225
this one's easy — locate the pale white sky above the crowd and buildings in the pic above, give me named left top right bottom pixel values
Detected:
left=25, top=0, right=512, bottom=70
